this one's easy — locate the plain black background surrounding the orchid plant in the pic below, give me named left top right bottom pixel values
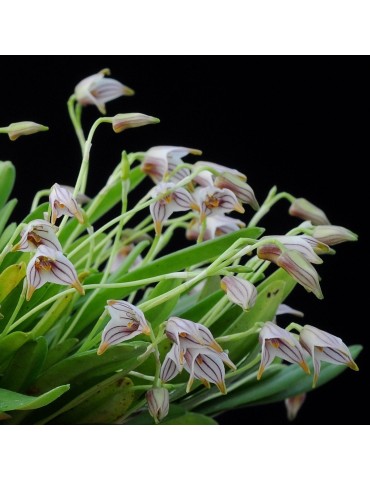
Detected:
left=0, top=56, right=369, bottom=424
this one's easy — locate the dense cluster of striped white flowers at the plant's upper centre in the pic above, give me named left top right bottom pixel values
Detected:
left=141, top=146, right=258, bottom=240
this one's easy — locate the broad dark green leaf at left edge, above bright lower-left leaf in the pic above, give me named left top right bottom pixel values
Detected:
left=1, top=337, right=48, bottom=392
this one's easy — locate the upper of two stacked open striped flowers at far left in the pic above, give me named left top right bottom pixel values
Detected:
left=13, top=220, right=62, bottom=252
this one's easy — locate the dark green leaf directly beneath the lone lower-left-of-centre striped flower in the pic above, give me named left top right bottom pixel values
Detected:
left=32, top=342, right=148, bottom=392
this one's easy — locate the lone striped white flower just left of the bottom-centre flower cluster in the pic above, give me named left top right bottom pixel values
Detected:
left=98, top=300, right=150, bottom=355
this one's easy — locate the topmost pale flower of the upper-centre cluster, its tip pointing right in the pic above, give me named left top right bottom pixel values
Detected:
left=141, top=146, right=202, bottom=183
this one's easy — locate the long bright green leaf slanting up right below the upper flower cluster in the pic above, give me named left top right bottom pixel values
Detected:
left=72, top=227, right=263, bottom=336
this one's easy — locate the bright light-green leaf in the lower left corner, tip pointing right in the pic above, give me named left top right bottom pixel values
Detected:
left=0, top=385, right=69, bottom=412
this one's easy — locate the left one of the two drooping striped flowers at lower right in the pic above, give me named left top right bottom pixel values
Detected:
left=257, top=322, right=310, bottom=380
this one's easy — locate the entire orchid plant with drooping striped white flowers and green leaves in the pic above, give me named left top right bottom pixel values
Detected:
left=0, top=69, right=361, bottom=424
